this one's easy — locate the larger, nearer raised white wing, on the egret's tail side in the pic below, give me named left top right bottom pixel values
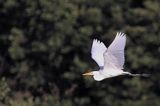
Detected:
left=104, top=32, right=126, bottom=69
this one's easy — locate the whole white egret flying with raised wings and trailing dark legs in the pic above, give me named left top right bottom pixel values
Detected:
left=83, top=32, right=148, bottom=81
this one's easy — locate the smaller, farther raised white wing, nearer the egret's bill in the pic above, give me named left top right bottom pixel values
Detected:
left=91, top=39, right=107, bottom=68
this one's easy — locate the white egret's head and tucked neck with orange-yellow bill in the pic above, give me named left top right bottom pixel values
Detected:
left=82, top=71, right=105, bottom=81
